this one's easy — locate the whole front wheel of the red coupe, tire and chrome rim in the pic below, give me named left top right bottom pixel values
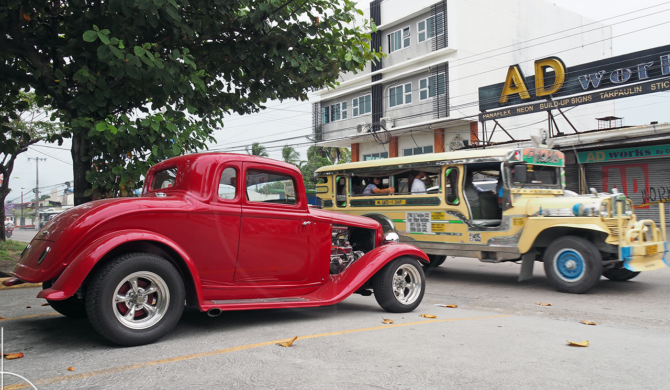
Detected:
left=372, top=256, right=426, bottom=313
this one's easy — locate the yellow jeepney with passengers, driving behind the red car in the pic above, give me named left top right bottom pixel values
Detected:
left=316, top=147, right=667, bottom=293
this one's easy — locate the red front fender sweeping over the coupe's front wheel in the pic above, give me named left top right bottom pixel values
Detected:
left=311, top=244, right=429, bottom=305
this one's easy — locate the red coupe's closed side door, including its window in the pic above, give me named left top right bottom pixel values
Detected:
left=235, top=163, right=313, bottom=283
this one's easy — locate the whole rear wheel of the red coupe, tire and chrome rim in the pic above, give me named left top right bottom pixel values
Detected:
left=86, top=253, right=186, bottom=345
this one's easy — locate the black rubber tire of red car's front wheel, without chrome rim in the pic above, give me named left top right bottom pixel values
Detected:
left=372, top=256, right=426, bottom=313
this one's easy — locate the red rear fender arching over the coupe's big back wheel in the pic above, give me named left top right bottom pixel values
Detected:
left=37, top=230, right=202, bottom=302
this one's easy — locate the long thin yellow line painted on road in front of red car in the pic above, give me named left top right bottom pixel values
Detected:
left=5, top=315, right=509, bottom=390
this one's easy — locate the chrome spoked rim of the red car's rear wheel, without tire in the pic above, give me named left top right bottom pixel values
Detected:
left=112, top=271, right=170, bottom=329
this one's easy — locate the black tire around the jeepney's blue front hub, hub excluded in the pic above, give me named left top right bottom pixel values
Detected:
left=544, top=236, right=603, bottom=294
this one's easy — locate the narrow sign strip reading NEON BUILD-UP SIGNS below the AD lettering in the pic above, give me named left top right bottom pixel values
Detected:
left=479, top=79, right=670, bottom=122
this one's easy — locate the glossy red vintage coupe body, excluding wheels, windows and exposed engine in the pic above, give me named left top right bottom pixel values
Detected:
left=5, top=153, right=428, bottom=311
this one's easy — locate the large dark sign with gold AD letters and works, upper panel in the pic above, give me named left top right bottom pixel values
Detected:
left=479, top=45, right=670, bottom=113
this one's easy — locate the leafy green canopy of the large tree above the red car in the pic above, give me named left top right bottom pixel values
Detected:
left=0, top=0, right=381, bottom=204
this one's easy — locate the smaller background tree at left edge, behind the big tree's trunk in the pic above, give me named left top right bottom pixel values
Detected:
left=0, top=93, right=63, bottom=241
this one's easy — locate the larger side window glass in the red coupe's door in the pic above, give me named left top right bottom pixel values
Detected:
left=246, top=169, right=298, bottom=205
